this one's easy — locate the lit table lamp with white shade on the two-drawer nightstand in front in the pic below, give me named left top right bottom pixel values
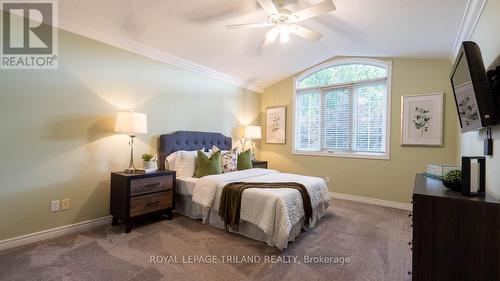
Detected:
left=115, top=112, right=148, bottom=173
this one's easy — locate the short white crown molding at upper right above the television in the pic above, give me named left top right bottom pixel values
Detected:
left=450, top=0, right=487, bottom=62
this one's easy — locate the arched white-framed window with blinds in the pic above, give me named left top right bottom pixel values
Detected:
left=294, top=59, right=391, bottom=159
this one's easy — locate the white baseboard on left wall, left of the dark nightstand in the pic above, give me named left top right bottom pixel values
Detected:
left=0, top=216, right=111, bottom=251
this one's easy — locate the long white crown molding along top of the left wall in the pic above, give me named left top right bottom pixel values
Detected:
left=59, top=18, right=264, bottom=93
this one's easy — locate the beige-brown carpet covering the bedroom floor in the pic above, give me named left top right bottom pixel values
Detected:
left=0, top=200, right=411, bottom=281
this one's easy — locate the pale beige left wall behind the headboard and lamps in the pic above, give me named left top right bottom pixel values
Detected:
left=0, top=32, right=261, bottom=240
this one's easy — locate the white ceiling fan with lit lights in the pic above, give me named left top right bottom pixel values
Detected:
left=226, top=0, right=335, bottom=45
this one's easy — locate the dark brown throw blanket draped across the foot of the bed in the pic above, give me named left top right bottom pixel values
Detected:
left=219, top=182, right=312, bottom=231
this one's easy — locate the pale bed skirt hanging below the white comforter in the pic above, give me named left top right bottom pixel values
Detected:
left=174, top=194, right=328, bottom=249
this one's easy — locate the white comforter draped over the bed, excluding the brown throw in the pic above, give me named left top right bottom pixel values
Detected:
left=193, top=169, right=330, bottom=249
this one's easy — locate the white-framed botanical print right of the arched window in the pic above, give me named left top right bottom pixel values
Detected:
left=401, top=93, right=443, bottom=146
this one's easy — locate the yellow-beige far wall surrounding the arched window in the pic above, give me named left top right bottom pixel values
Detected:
left=261, top=59, right=458, bottom=203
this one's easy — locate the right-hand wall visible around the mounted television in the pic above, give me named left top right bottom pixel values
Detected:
left=461, top=0, right=500, bottom=199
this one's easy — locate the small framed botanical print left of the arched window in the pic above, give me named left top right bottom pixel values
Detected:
left=266, top=106, right=286, bottom=144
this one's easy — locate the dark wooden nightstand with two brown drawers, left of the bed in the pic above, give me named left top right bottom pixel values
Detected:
left=110, top=170, right=175, bottom=233
